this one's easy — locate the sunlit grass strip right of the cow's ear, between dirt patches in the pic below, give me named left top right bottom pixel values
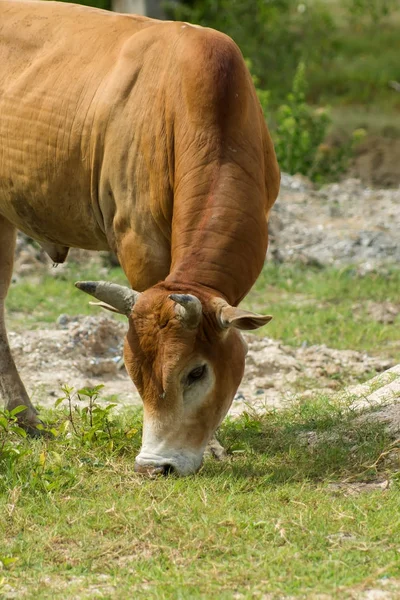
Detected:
left=244, top=264, right=400, bottom=359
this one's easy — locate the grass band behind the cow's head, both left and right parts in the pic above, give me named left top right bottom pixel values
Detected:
left=7, top=263, right=400, bottom=359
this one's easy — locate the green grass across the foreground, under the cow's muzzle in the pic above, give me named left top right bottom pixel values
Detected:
left=0, top=398, right=400, bottom=599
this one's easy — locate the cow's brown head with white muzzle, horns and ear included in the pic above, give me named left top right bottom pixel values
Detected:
left=76, top=281, right=271, bottom=475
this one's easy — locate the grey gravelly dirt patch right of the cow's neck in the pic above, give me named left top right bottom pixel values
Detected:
left=269, top=174, right=400, bottom=272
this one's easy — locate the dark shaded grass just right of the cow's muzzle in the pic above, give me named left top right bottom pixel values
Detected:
left=212, top=398, right=392, bottom=484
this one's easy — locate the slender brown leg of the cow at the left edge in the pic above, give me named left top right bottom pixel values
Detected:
left=0, top=216, right=40, bottom=434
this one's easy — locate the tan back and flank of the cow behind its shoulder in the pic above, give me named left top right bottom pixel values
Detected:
left=0, top=0, right=157, bottom=249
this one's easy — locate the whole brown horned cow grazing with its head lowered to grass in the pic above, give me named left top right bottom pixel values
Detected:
left=0, top=0, right=279, bottom=475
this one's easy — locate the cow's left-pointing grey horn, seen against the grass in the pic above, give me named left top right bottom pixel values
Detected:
left=75, top=281, right=140, bottom=317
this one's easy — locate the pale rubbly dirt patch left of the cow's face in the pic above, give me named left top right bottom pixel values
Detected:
left=9, top=315, right=135, bottom=406
